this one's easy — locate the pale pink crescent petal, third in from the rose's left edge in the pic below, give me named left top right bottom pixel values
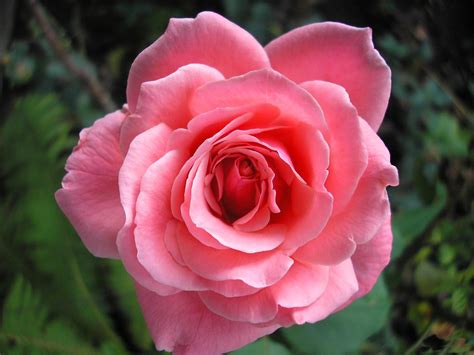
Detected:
left=134, top=151, right=257, bottom=296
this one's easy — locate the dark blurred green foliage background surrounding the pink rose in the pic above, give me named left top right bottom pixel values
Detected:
left=0, top=0, right=474, bottom=355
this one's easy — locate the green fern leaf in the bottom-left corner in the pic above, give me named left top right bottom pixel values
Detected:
left=0, top=277, right=97, bottom=355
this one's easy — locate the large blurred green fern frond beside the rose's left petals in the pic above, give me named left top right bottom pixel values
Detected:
left=0, top=95, right=125, bottom=344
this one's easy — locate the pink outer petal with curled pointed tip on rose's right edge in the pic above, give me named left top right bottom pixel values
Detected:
left=293, top=120, right=398, bottom=265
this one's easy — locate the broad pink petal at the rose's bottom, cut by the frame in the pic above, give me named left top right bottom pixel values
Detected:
left=137, top=285, right=279, bottom=355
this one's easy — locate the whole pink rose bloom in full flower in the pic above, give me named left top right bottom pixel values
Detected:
left=56, top=12, right=398, bottom=354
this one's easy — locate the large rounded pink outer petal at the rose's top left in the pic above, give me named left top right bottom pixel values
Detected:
left=127, top=12, right=269, bottom=112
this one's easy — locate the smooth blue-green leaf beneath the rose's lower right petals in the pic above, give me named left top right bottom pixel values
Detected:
left=283, top=278, right=390, bottom=355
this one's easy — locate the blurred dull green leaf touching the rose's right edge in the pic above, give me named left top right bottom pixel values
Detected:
left=392, top=182, right=447, bottom=259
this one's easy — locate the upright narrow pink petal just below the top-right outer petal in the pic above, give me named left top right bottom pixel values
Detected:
left=301, top=80, right=367, bottom=214
